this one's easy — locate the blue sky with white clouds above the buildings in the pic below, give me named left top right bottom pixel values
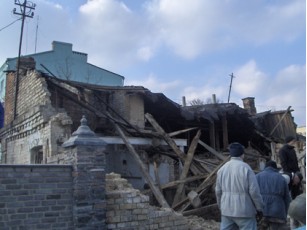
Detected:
left=0, top=0, right=306, bottom=126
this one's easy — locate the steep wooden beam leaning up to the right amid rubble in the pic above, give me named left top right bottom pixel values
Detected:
left=173, top=130, right=201, bottom=207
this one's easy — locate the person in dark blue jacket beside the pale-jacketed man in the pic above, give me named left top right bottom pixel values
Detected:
left=256, top=160, right=291, bottom=230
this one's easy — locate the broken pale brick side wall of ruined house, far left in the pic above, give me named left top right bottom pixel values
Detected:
left=0, top=70, right=71, bottom=164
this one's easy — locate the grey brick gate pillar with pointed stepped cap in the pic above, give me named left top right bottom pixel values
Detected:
left=62, top=116, right=106, bottom=230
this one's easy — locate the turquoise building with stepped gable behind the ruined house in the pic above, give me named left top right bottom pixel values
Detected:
left=0, top=41, right=124, bottom=102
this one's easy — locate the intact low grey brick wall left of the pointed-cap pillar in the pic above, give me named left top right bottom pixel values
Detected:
left=0, top=165, right=73, bottom=230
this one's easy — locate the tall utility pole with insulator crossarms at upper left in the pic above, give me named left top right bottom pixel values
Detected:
left=13, top=0, right=36, bottom=119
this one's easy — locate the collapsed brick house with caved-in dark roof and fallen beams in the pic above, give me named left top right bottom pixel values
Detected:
left=0, top=58, right=306, bottom=220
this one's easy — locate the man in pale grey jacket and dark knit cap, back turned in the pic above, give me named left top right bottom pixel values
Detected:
left=215, top=142, right=263, bottom=230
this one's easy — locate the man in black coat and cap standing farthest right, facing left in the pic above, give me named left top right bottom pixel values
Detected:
left=279, top=136, right=303, bottom=199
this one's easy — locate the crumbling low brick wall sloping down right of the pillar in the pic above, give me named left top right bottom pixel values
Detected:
left=106, top=173, right=212, bottom=230
